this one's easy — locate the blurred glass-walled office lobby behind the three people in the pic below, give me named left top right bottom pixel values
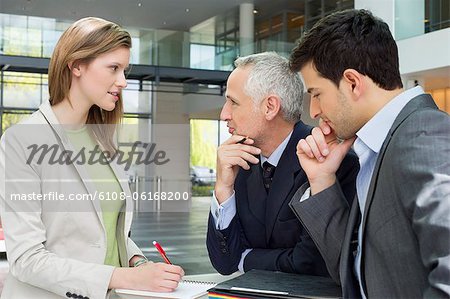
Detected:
left=0, top=0, right=450, bottom=290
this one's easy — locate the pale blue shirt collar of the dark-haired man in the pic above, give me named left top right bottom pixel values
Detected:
left=355, top=86, right=424, bottom=154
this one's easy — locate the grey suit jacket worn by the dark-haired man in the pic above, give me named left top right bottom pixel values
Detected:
left=291, top=95, right=450, bottom=298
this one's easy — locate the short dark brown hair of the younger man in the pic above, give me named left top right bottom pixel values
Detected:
left=290, top=9, right=403, bottom=90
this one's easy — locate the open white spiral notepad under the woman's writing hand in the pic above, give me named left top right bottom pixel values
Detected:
left=116, top=280, right=216, bottom=299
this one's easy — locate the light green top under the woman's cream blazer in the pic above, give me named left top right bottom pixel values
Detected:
left=66, top=126, right=124, bottom=267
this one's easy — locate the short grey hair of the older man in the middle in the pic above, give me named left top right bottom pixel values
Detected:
left=234, top=52, right=304, bottom=122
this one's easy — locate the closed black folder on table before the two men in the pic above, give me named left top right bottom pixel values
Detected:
left=208, top=270, right=342, bottom=298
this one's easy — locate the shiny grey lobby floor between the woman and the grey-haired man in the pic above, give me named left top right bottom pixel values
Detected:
left=0, top=197, right=216, bottom=292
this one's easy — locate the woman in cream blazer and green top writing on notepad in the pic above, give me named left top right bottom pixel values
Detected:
left=0, top=17, right=184, bottom=299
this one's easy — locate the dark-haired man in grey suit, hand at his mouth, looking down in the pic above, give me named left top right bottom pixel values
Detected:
left=291, top=10, right=450, bottom=298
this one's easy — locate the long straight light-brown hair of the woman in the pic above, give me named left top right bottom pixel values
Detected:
left=48, top=17, right=131, bottom=154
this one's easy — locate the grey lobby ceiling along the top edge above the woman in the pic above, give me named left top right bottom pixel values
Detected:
left=0, top=0, right=303, bottom=31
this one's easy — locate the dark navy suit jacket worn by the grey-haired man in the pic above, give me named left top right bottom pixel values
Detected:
left=207, top=122, right=359, bottom=276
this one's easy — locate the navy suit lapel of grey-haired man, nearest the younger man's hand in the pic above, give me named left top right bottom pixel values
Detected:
left=265, top=121, right=311, bottom=242
